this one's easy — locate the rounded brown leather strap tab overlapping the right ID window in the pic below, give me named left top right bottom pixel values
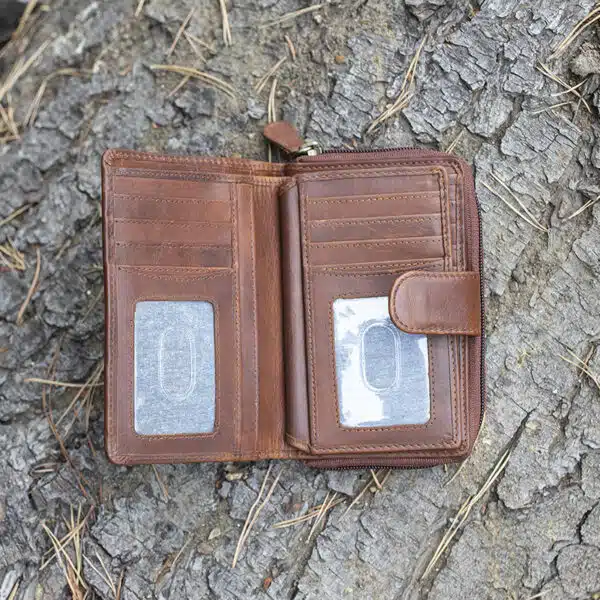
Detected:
left=390, top=271, right=481, bottom=336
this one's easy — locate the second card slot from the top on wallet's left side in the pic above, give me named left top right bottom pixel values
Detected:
left=114, top=194, right=231, bottom=223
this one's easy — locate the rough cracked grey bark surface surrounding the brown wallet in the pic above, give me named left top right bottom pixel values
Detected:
left=0, top=0, right=600, bottom=600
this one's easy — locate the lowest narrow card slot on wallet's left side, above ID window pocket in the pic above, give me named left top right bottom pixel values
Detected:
left=114, top=241, right=232, bottom=267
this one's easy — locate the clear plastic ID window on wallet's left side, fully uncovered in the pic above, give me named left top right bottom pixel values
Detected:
left=134, top=300, right=215, bottom=435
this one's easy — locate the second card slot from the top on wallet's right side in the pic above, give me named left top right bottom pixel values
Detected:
left=307, top=190, right=440, bottom=221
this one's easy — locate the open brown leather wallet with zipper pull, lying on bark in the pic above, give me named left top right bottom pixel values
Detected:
left=102, top=122, right=485, bottom=468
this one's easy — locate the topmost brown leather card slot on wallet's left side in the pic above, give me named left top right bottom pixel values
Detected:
left=112, top=176, right=230, bottom=202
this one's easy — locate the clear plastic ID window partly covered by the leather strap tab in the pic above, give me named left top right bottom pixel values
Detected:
left=333, top=296, right=430, bottom=427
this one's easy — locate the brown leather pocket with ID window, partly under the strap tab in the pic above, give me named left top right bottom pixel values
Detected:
left=307, top=272, right=464, bottom=454
